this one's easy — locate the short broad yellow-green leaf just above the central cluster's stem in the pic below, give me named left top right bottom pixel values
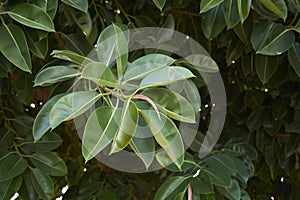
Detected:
left=81, top=62, right=117, bottom=87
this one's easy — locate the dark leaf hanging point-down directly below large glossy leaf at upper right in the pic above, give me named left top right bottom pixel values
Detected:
left=255, top=55, right=278, bottom=84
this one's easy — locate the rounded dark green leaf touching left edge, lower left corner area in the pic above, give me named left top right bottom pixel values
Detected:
left=0, top=154, right=28, bottom=181
